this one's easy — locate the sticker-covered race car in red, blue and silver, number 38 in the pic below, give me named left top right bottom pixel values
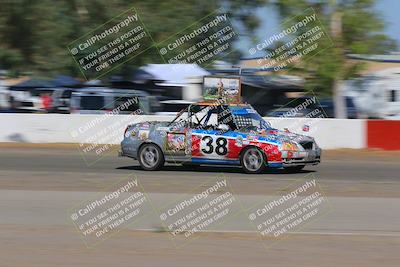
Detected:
left=119, top=103, right=321, bottom=173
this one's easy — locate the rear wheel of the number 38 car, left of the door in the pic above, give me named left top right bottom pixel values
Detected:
left=138, top=143, right=165, bottom=171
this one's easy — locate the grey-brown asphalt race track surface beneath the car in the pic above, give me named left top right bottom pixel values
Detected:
left=0, top=147, right=400, bottom=266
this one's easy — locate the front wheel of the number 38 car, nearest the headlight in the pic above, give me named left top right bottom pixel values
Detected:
left=240, top=146, right=266, bottom=173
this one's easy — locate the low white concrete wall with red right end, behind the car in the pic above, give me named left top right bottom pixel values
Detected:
left=0, top=113, right=400, bottom=149
